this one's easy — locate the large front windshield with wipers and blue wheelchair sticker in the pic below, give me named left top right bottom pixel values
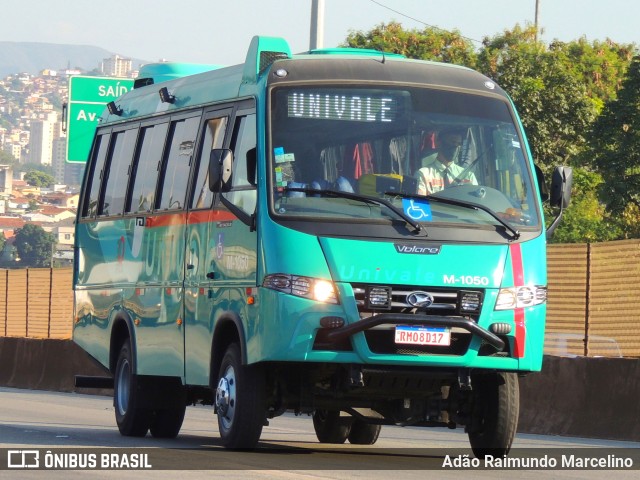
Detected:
left=270, top=85, right=541, bottom=235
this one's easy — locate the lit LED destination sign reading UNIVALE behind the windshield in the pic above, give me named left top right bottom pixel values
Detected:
left=287, top=91, right=398, bottom=122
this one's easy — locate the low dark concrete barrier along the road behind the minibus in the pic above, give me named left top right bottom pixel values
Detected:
left=0, top=337, right=640, bottom=441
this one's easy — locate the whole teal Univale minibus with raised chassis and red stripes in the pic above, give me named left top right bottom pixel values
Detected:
left=73, top=37, right=571, bottom=456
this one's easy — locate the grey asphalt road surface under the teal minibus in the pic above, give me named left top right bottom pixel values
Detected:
left=0, top=388, right=640, bottom=480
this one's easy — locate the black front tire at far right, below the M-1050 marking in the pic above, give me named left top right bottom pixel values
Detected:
left=468, top=373, right=520, bottom=458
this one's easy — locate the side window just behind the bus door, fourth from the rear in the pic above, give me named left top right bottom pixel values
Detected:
left=157, top=115, right=200, bottom=210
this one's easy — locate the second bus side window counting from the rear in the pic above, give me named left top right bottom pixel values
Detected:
left=98, top=127, right=138, bottom=215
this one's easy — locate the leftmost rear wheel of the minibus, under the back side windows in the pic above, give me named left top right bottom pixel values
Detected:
left=113, top=340, right=151, bottom=437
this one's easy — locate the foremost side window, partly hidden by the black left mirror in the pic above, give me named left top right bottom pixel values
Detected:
left=224, top=114, right=257, bottom=214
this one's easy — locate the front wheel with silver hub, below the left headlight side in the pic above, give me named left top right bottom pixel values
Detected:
left=215, top=343, right=266, bottom=449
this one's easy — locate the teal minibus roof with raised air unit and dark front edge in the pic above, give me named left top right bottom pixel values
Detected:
left=100, top=36, right=505, bottom=126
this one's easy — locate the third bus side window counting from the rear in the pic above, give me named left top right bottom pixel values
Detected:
left=126, top=122, right=169, bottom=213
